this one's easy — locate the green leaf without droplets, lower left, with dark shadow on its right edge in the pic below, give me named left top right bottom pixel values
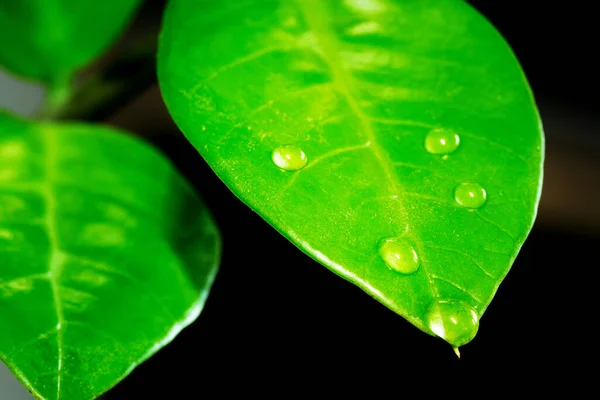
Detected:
left=0, top=113, right=220, bottom=400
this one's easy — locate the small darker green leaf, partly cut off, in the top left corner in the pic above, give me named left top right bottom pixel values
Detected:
left=0, top=0, right=140, bottom=83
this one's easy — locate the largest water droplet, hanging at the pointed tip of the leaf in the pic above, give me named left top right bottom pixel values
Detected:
left=428, top=300, right=479, bottom=347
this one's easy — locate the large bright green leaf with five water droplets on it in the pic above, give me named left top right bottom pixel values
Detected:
left=159, top=0, right=543, bottom=347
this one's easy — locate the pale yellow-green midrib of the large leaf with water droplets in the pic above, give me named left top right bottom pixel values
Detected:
left=296, top=0, right=439, bottom=306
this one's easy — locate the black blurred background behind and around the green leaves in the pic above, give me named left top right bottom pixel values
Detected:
left=0, top=0, right=600, bottom=400
